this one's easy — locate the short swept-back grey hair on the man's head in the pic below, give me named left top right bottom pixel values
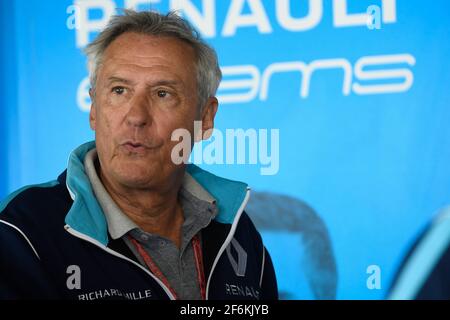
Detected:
left=84, top=9, right=222, bottom=108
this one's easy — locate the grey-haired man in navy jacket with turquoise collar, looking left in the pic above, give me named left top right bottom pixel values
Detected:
left=0, top=11, right=278, bottom=300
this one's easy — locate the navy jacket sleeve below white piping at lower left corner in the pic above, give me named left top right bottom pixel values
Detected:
left=0, top=221, right=56, bottom=300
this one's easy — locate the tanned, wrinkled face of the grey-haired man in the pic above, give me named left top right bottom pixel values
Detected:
left=90, top=33, right=217, bottom=189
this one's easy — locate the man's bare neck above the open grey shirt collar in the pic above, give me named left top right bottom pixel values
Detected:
left=97, top=165, right=184, bottom=248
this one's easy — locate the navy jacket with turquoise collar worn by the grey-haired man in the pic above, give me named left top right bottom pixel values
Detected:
left=0, top=142, right=278, bottom=300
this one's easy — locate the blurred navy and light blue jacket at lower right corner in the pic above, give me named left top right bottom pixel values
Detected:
left=389, top=207, right=450, bottom=300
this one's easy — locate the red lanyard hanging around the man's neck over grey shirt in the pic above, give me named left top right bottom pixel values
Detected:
left=128, top=235, right=206, bottom=300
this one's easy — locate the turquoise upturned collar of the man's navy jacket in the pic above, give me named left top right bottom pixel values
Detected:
left=65, top=141, right=248, bottom=246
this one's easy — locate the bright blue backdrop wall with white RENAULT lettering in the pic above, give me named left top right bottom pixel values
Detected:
left=0, top=0, right=450, bottom=299
